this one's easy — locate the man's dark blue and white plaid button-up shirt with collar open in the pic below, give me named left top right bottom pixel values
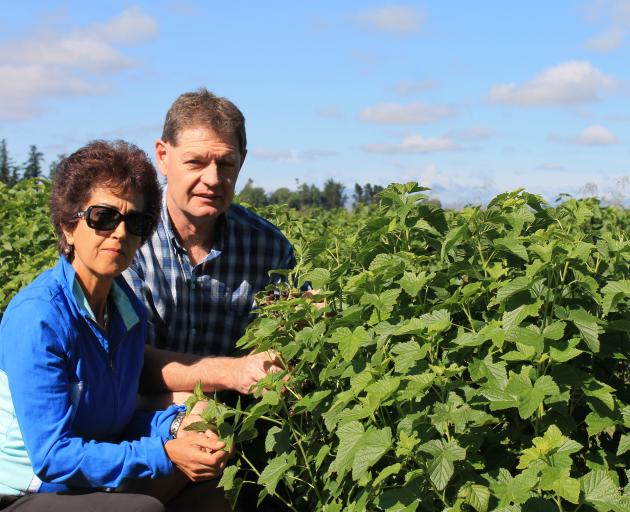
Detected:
left=123, top=201, right=295, bottom=355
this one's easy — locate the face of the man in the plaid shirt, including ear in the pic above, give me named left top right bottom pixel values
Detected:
left=155, top=127, right=245, bottom=223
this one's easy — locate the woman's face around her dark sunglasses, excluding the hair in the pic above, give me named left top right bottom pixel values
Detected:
left=64, top=187, right=145, bottom=286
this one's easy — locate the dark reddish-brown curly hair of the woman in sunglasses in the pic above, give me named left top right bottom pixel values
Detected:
left=50, top=140, right=162, bottom=261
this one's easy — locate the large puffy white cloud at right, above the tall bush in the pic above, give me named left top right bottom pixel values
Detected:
left=489, top=61, right=617, bottom=106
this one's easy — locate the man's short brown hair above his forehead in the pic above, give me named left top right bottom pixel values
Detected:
left=162, top=87, right=247, bottom=155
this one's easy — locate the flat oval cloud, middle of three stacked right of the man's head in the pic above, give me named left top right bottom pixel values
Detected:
left=361, top=103, right=455, bottom=124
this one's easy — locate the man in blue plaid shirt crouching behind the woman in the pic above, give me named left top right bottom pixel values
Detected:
left=125, top=89, right=295, bottom=401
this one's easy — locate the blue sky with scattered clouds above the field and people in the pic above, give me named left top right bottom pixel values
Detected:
left=0, top=0, right=630, bottom=205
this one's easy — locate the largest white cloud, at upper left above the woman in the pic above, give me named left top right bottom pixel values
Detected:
left=0, top=7, right=157, bottom=121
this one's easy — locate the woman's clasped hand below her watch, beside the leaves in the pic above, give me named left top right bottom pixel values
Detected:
left=164, top=430, right=230, bottom=482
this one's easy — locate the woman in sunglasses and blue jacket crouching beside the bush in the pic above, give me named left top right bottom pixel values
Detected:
left=0, top=141, right=228, bottom=511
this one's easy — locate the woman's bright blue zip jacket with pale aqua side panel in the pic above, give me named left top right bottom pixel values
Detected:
left=0, top=257, right=181, bottom=494
